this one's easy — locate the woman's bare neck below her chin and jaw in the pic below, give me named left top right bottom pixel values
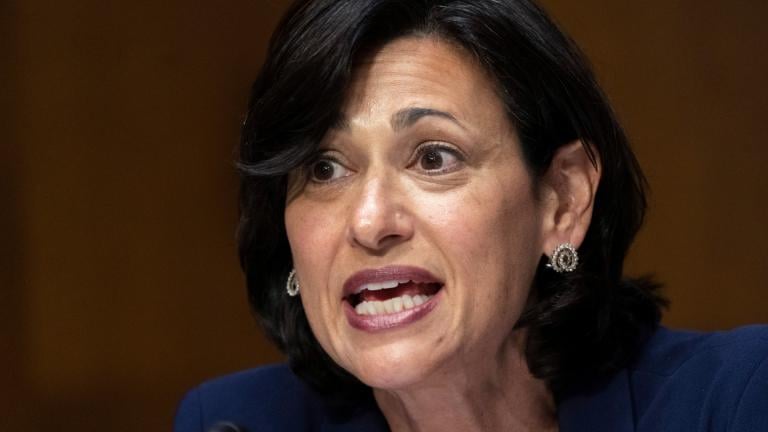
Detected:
left=374, top=334, right=557, bottom=432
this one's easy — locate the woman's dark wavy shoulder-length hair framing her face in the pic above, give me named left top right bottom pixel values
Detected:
left=238, top=0, right=665, bottom=396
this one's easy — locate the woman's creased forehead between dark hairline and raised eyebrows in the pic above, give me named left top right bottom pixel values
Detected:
left=343, top=36, right=504, bottom=124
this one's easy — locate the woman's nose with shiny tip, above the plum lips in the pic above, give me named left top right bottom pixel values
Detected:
left=348, top=177, right=413, bottom=254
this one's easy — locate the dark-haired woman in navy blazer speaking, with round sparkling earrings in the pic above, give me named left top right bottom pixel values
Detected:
left=176, top=0, right=768, bottom=431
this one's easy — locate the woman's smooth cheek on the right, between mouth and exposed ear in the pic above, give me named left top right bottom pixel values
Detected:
left=433, top=180, right=540, bottom=328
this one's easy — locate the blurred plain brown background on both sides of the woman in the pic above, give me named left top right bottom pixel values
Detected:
left=6, top=0, right=768, bottom=431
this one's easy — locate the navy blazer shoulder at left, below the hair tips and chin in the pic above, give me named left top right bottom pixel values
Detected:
left=174, top=365, right=390, bottom=432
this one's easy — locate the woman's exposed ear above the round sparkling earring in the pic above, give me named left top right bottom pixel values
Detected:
left=540, top=140, right=601, bottom=256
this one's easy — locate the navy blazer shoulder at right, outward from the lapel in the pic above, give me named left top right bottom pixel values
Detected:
left=628, top=326, right=768, bottom=431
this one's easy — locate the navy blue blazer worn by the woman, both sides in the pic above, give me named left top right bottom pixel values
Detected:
left=174, top=326, right=768, bottom=432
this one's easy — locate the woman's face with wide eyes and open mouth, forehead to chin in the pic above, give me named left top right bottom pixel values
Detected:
left=285, top=37, right=544, bottom=389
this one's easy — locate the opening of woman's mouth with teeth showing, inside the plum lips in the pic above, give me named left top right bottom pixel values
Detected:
left=344, top=280, right=443, bottom=315
